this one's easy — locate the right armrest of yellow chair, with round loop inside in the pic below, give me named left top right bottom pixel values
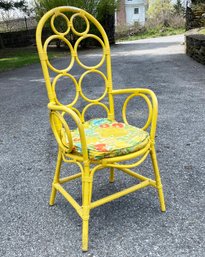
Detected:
left=111, top=88, right=158, bottom=141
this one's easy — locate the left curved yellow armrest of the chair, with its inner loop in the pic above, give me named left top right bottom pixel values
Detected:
left=48, top=103, right=88, bottom=159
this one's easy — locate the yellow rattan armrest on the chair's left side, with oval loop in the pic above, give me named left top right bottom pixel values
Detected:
left=48, top=103, right=88, bottom=159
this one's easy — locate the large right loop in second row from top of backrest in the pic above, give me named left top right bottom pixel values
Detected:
left=74, top=34, right=105, bottom=70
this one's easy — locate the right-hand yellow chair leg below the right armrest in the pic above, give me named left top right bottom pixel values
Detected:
left=150, top=146, right=166, bottom=212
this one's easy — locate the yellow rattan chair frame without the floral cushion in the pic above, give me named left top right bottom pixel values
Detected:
left=36, top=6, right=165, bottom=251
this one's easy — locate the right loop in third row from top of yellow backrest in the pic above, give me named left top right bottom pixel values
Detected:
left=79, top=70, right=107, bottom=103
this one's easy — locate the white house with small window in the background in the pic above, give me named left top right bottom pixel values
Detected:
left=116, top=0, right=146, bottom=25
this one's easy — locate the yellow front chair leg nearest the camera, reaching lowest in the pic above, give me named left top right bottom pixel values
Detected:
left=82, top=164, right=92, bottom=252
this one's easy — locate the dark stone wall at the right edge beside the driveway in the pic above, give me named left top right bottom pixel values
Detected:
left=185, top=29, right=205, bottom=64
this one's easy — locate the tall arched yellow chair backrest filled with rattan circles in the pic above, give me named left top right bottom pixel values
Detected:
left=36, top=6, right=114, bottom=122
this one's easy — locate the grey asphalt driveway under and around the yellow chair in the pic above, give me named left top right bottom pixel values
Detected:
left=0, top=36, right=205, bottom=257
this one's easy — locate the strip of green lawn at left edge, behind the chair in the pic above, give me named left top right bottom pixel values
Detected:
left=0, top=47, right=63, bottom=72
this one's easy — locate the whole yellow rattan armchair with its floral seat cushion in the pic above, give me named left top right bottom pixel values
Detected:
left=36, top=6, right=165, bottom=251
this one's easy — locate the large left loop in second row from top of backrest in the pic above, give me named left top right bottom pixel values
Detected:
left=44, top=35, right=75, bottom=73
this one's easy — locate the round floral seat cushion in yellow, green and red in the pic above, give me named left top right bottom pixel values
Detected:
left=72, top=118, right=149, bottom=160
